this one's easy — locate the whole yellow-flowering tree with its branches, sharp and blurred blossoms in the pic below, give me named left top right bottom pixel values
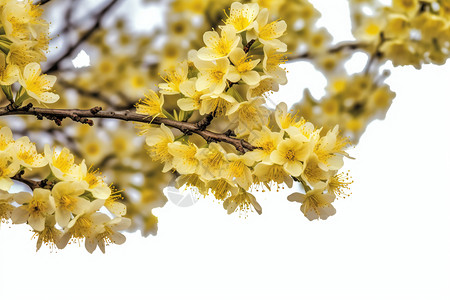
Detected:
left=0, top=0, right=444, bottom=252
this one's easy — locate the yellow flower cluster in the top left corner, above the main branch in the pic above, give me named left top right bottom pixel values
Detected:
left=0, top=0, right=59, bottom=106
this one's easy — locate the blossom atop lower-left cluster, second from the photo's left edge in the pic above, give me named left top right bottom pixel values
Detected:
left=13, top=136, right=47, bottom=169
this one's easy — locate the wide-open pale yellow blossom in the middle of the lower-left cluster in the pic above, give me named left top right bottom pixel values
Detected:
left=52, top=181, right=90, bottom=227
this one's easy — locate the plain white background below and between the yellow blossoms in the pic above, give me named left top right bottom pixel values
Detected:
left=0, top=0, right=450, bottom=300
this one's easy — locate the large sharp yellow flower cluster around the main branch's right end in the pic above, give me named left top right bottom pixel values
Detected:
left=137, top=2, right=350, bottom=220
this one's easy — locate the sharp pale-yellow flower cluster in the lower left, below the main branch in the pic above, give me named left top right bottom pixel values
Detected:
left=0, top=127, right=131, bottom=253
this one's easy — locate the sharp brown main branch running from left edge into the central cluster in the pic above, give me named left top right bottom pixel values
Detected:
left=0, top=105, right=256, bottom=153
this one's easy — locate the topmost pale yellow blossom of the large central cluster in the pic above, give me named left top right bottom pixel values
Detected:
left=225, top=2, right=259, bottom=33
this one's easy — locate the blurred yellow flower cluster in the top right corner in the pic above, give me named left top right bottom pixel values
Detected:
left=352, top=0, right=450, bottom=69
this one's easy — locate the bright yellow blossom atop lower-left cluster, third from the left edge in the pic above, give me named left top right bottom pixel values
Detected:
left=44, top=145, right=81, bottom=181
